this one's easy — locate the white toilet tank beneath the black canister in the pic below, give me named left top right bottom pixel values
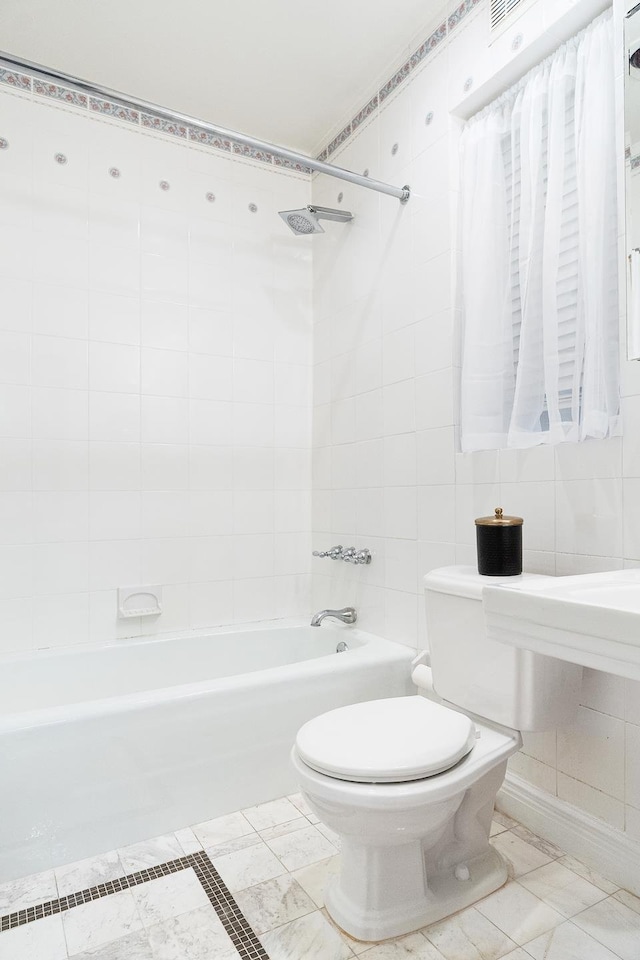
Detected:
left=424, top=567, right=582, bottom=730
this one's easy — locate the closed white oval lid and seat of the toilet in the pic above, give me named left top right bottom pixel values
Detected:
left=296, top=696, right=476, bottom=783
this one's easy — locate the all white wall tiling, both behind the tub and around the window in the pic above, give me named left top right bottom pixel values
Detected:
left=0, top=0, right=640, bottom=860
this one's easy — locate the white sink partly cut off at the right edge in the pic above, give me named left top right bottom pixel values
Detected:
left=482, top=569, right=640, bottom=680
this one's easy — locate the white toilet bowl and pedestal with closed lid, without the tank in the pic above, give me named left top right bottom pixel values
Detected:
left=292, top=696, right=521, bottom=940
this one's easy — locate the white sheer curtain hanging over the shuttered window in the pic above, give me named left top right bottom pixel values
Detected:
left=460, top=12, right=619, bottom=450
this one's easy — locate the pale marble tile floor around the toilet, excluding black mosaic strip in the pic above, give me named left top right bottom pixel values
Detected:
left=0, top=795, right=640, bottom=960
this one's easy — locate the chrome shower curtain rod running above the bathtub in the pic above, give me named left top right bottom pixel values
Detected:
left=0, top=51, right=411, bottom=203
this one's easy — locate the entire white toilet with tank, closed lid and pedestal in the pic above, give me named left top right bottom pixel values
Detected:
left=292, top=567, right=582, bottom=940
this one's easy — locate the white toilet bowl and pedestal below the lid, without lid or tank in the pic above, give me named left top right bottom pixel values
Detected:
left=292, top=725, right=521, bottom=942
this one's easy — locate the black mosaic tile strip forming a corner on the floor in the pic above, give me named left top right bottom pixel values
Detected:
left=0, top=850, right=269, bottom=960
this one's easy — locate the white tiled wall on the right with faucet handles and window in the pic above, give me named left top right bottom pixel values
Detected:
left=313, top=2, right=640, bottom=837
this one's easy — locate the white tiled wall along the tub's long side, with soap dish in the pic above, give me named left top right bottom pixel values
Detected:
left=0, top=88, right=312, bottom=652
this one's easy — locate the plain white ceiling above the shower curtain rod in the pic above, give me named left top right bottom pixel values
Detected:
left=0, top=0, right=441, bottom=153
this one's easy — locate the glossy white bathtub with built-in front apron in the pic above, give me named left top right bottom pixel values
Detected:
left=0, top=623, right=414, bottom=882
